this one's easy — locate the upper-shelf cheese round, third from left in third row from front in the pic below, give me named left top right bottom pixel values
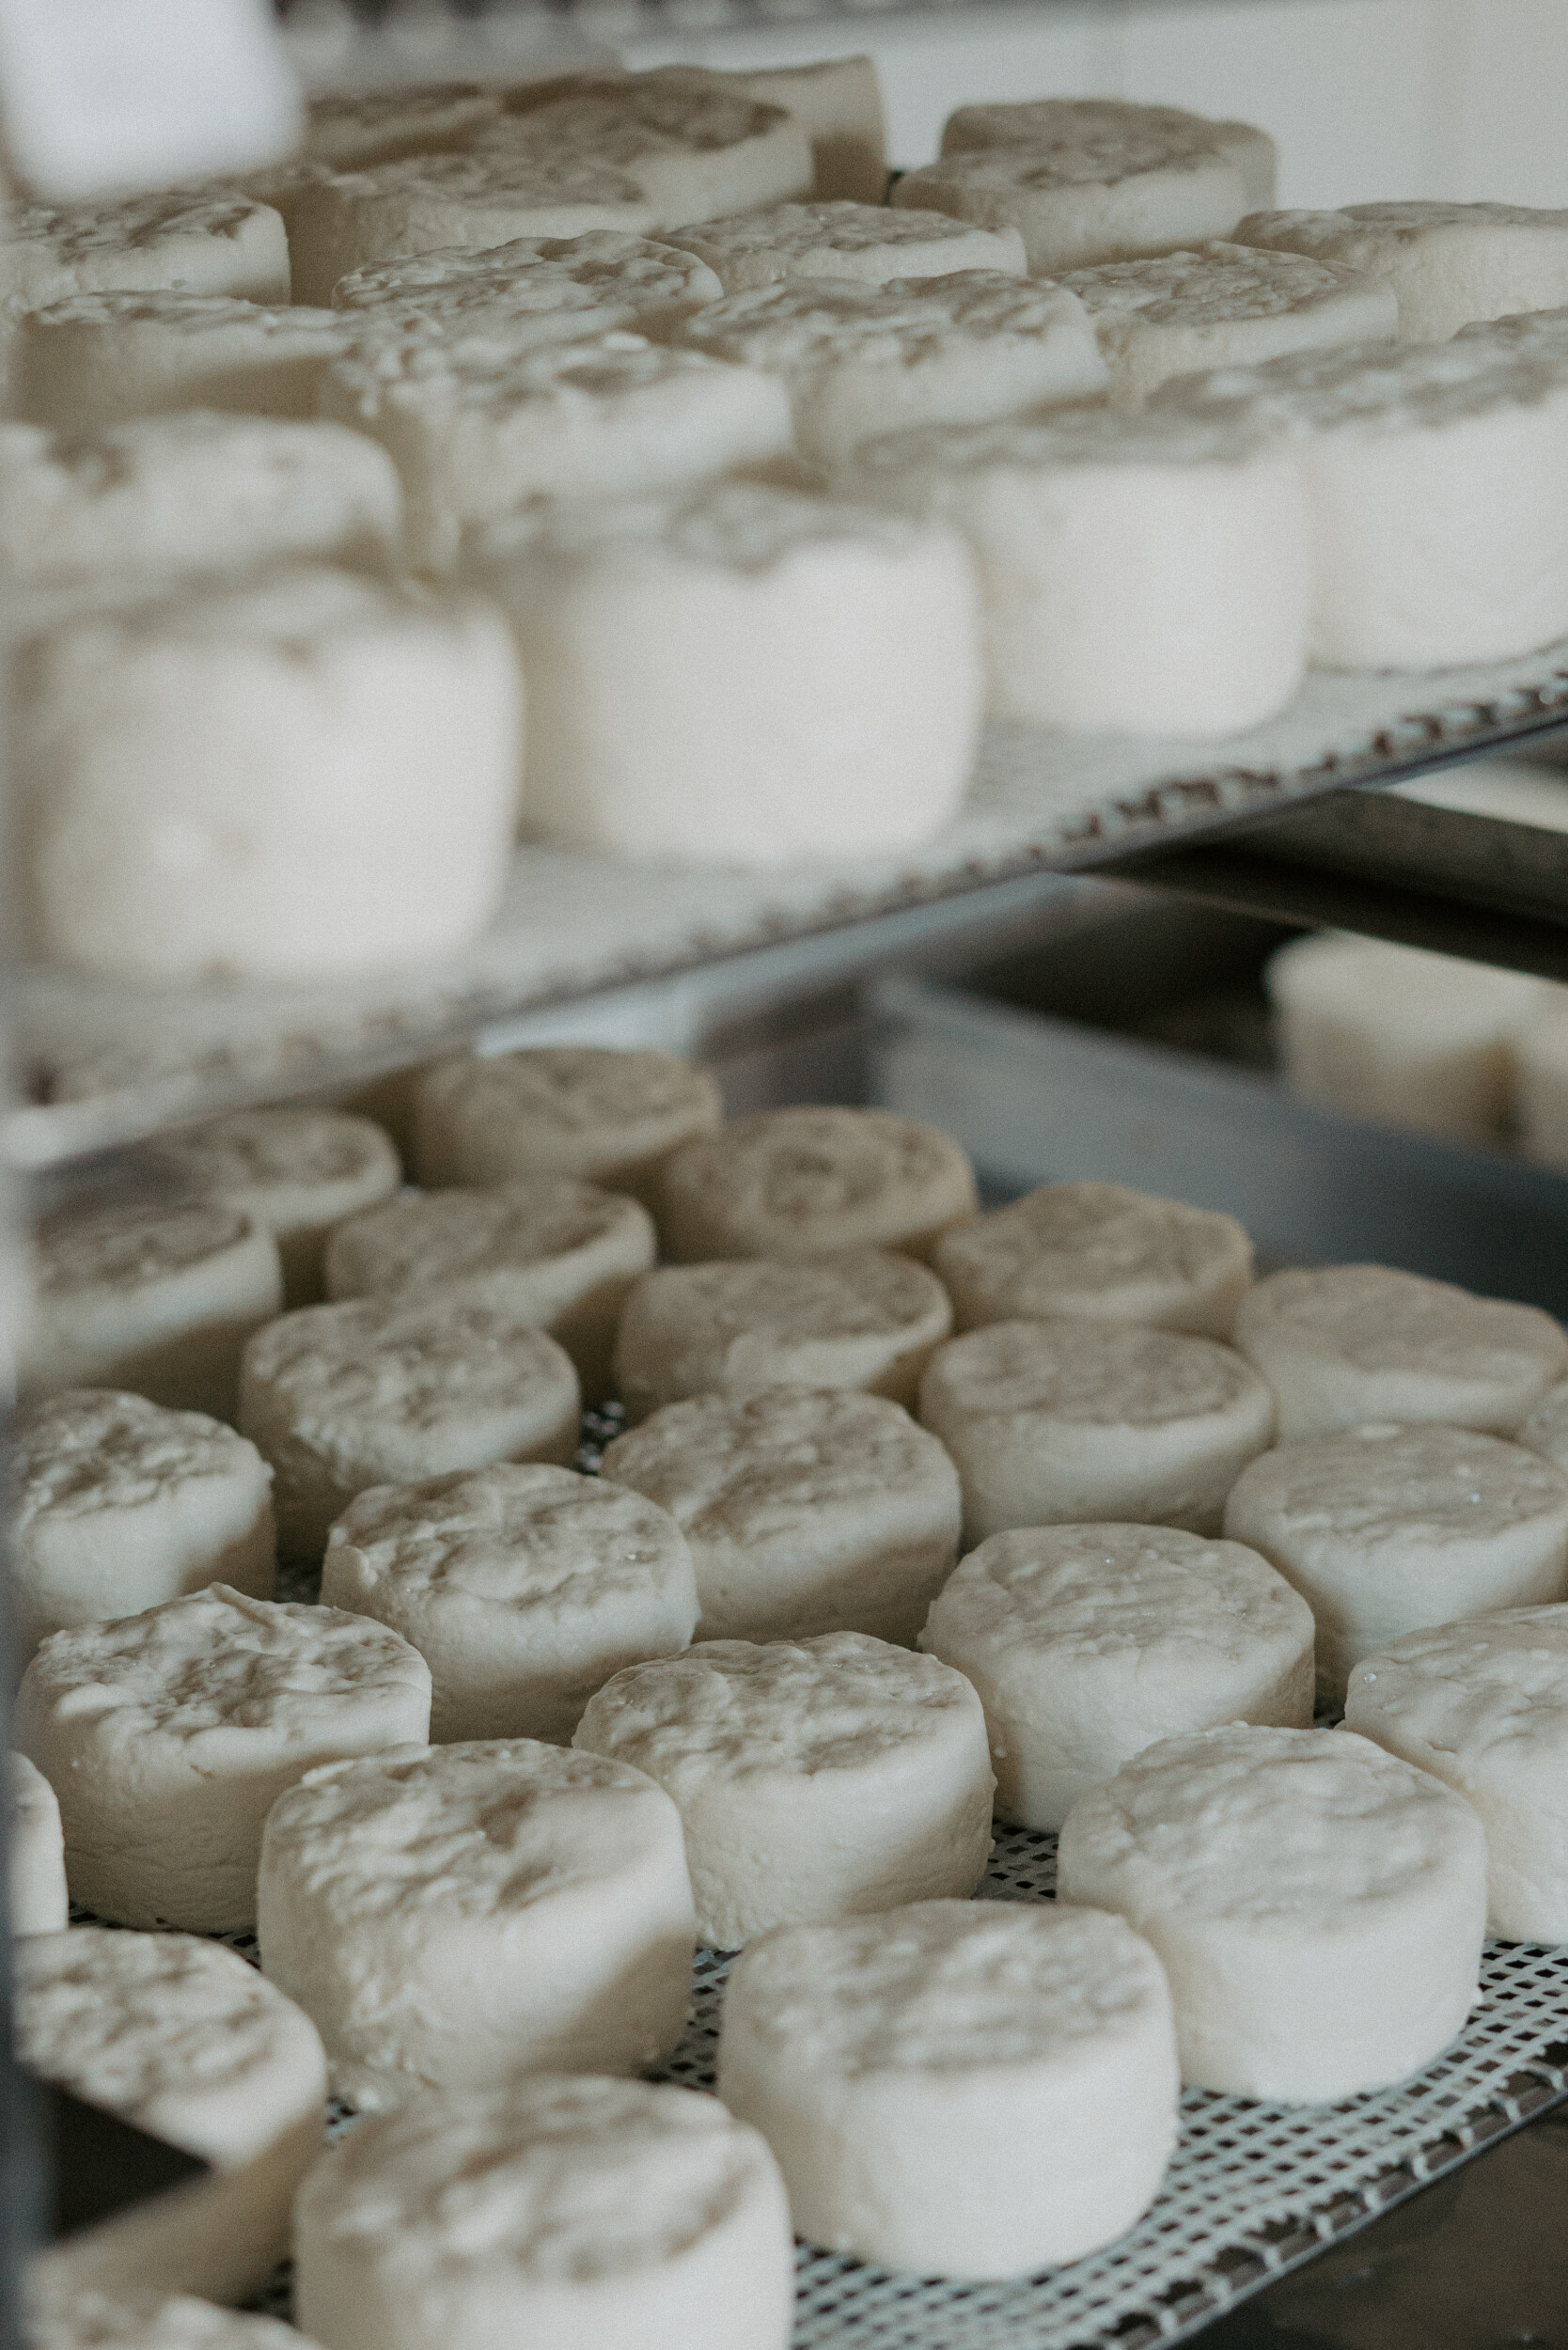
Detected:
left=670, top=200, right=1023, bottom=299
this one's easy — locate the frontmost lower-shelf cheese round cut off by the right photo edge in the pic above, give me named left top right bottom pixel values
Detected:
left=1344, top=1606, right=1568, bottom=1941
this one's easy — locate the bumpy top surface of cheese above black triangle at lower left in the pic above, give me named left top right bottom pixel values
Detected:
left=14, top=1927, right=327, bottom=2170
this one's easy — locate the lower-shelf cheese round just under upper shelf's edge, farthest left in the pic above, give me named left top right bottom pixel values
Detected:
left=153, top=1109, right=402, bottom=1307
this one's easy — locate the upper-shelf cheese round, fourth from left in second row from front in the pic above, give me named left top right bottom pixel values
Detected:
left=1060, top=243, right=1399, bottom=409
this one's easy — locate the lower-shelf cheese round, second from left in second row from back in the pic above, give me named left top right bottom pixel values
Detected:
left=327, top=1175, right=658, bottom=1401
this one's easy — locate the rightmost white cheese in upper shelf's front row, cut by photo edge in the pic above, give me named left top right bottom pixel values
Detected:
left=1154, top=338, right=1568, bottom=670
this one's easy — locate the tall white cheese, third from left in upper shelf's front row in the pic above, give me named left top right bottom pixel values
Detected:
left=837, top=409, right=1311, bottom=736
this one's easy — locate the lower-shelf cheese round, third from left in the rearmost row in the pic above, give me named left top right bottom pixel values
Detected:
left=931, top=1183, right=1253, bottom=1338
